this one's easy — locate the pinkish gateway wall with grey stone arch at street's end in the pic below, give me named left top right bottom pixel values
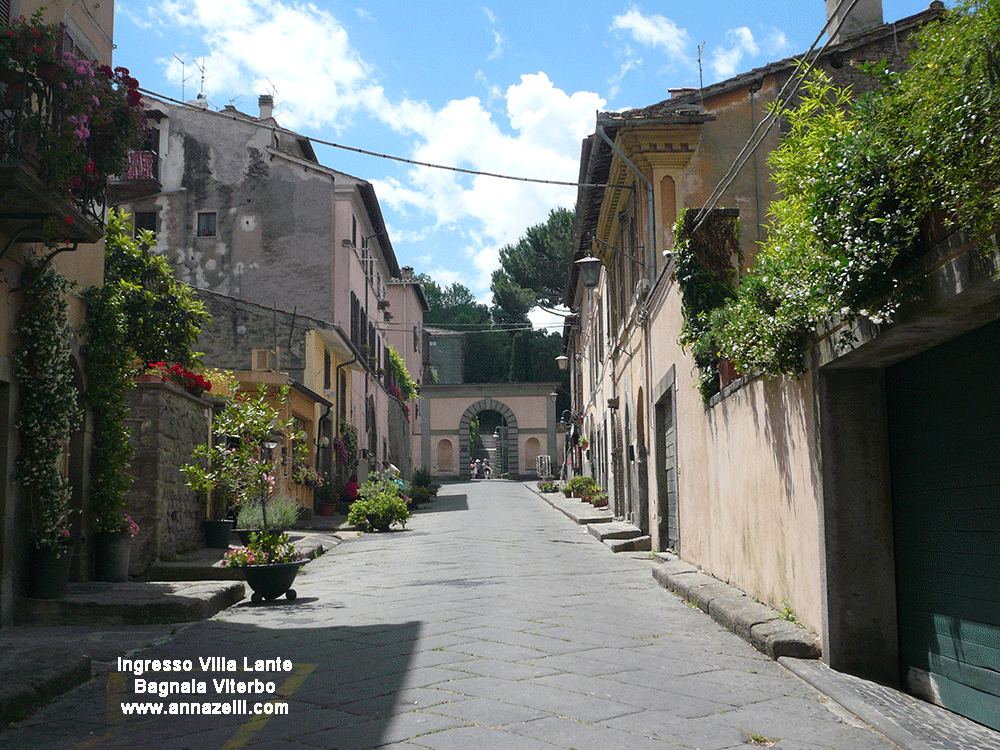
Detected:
left=414, top=383, right=563, bottom=479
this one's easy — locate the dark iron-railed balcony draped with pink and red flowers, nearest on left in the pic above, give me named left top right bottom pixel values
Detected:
left=0, top=71, right=105, bottom=243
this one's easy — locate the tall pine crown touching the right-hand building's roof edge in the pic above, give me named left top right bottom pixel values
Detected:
left=491, top=208, right=574, bottom=324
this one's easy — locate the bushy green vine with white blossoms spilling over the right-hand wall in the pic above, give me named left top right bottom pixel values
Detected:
left=677, top=0, right=1000, bottom=384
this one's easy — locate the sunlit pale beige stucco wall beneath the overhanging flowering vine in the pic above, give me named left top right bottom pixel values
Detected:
left=649, top=276, right=822, bottom=632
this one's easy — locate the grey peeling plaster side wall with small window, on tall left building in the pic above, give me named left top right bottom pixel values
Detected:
left=126, top=104, right=335, bottom=320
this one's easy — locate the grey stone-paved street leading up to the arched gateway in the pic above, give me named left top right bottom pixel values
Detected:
left=0, top=481, right=916, bottom=750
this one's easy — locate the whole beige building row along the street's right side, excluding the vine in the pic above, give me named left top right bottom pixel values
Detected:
left=564, top=3, right=988, bottom=704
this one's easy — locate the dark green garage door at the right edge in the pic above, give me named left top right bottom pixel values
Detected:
left=887, top=322, right=1000, bottom=729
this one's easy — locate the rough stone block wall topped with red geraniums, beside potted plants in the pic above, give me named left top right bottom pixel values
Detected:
left=126, top=383, right=211, bottom=575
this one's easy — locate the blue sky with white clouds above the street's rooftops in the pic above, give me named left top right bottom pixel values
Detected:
left=115, top=0, right=929, bottom=321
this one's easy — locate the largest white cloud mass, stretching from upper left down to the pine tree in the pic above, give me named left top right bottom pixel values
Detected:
left=145, top=0, right=606, bottom=306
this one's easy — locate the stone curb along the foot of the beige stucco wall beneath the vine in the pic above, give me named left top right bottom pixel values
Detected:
left=653, top=557, right=822, bottom=660
